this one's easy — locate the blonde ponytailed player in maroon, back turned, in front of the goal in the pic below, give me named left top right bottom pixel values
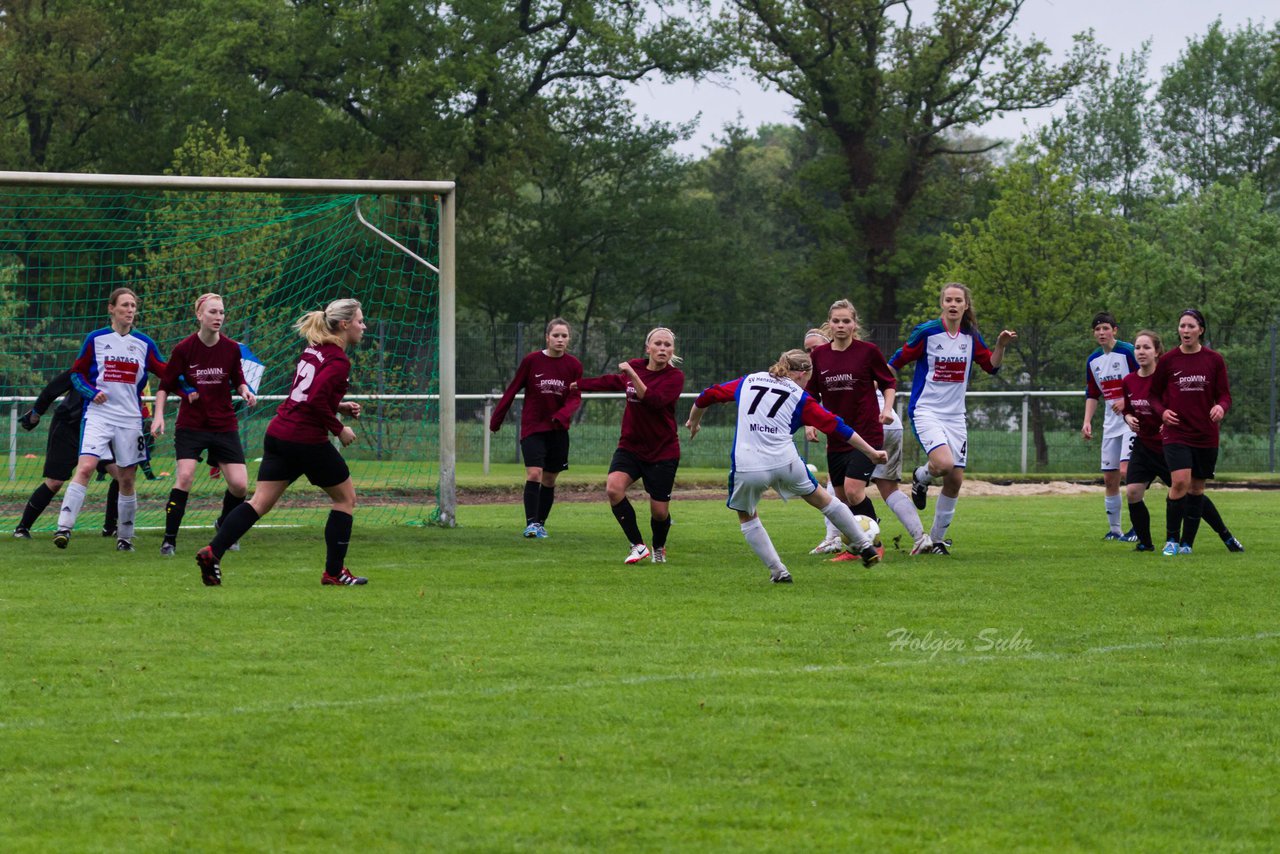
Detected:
left=196, top=300, right=369, bottom=586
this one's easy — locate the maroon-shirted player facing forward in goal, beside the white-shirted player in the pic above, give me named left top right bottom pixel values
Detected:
left=151, top=293, right=257, bottom=557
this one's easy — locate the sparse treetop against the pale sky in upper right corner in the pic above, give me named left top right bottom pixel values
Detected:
left=1155, top=20, right=1280, bottom=200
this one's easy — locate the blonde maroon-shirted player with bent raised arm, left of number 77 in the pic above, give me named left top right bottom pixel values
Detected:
left=577, top=326, right=685, bottom=563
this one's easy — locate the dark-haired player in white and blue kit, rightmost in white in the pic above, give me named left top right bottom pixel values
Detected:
left=1080, top=311, right=1138, bottom=543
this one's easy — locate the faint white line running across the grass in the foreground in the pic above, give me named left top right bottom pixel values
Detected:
left=0, top=631, right=1280, bottom=731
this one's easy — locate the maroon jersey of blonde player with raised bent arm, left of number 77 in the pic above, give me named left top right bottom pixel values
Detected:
left=577, top=359, right=685, bottom=462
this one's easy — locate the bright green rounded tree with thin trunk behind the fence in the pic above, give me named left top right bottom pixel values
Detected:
left=931, top=147, right=1126, bottom=466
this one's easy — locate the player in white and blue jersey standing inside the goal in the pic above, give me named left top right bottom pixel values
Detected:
left=54, top=288, right=164, bottom=552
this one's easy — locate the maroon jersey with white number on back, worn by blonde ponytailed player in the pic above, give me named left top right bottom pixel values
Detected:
left=266, top=344, right=351, bottom=444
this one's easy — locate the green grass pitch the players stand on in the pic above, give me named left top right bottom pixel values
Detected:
left=0, top=492, right=1280, bottom=851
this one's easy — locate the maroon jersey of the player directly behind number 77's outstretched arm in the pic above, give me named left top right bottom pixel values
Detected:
left=805, top=341, right=897, bottom=452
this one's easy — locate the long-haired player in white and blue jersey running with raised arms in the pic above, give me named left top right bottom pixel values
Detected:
left=888, top=282, right=1018, bottom=554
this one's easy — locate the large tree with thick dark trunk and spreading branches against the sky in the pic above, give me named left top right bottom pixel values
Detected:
left=733, top=0, right=1096, bottom=323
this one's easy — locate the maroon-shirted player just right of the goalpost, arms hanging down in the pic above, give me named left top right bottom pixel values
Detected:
left=489, top=318, right=582, bottom=539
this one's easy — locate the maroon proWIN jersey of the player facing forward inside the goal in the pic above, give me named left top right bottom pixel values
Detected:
left=160, top=334, right=244, bottom=433
